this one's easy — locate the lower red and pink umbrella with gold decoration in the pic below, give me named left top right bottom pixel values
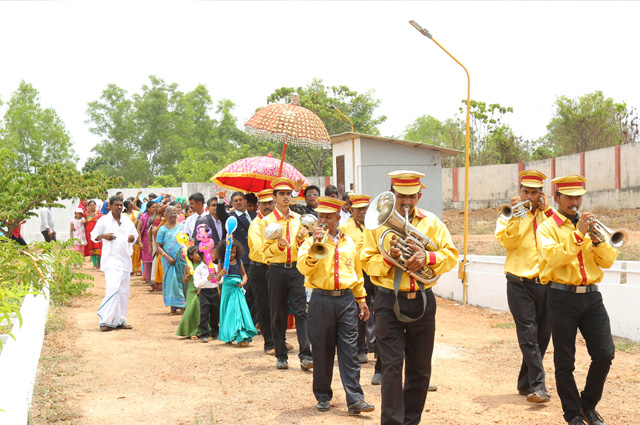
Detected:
left=211, top=155, right=309, bottom=193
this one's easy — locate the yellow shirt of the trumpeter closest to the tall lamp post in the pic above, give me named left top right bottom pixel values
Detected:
left=496, top=207, right=553, bottom=279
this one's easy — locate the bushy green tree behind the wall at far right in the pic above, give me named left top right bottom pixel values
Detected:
left=547, top=91, right=638, bottom=155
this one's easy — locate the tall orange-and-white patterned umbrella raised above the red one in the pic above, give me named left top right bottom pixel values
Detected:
left=244, top=94, right=331, bottom=176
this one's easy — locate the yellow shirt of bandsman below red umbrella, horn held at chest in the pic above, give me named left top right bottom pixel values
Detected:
left=260, top=208, right=304, bottom=264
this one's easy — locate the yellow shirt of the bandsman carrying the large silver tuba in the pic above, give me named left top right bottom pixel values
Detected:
left=360, top=208, right=458, bottom=292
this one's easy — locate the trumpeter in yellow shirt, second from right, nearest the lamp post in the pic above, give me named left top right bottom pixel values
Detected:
left=496, top=170, right=553, bottom=403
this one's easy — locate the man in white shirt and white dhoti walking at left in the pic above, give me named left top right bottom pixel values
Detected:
left=91, top=196, right=138, bottom=332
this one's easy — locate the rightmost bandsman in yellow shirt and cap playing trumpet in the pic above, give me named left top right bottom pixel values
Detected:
left=537, top=175, right=618, bottom=425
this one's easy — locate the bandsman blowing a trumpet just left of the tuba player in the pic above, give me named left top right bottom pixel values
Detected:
left=297, top=197, right=374, bottom=415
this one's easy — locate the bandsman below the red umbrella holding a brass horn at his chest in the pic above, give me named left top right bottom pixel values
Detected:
left=260, top=177, right=313, bottom=370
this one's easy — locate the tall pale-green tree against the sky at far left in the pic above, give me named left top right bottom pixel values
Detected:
left=0, top=81, right=78, bottom=171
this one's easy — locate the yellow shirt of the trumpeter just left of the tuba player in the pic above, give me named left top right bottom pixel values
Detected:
left=297, top=232, right=367, bottom=302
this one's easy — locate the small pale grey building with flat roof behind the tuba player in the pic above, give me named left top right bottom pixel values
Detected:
left=331, top=133, right=463, bottom=218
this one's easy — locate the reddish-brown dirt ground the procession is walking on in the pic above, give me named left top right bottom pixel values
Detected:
left=31, top=210, right=640, bottom=425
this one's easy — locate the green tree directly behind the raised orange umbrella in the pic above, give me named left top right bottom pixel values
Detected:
left=267, top=78, right=387, bottom=176
